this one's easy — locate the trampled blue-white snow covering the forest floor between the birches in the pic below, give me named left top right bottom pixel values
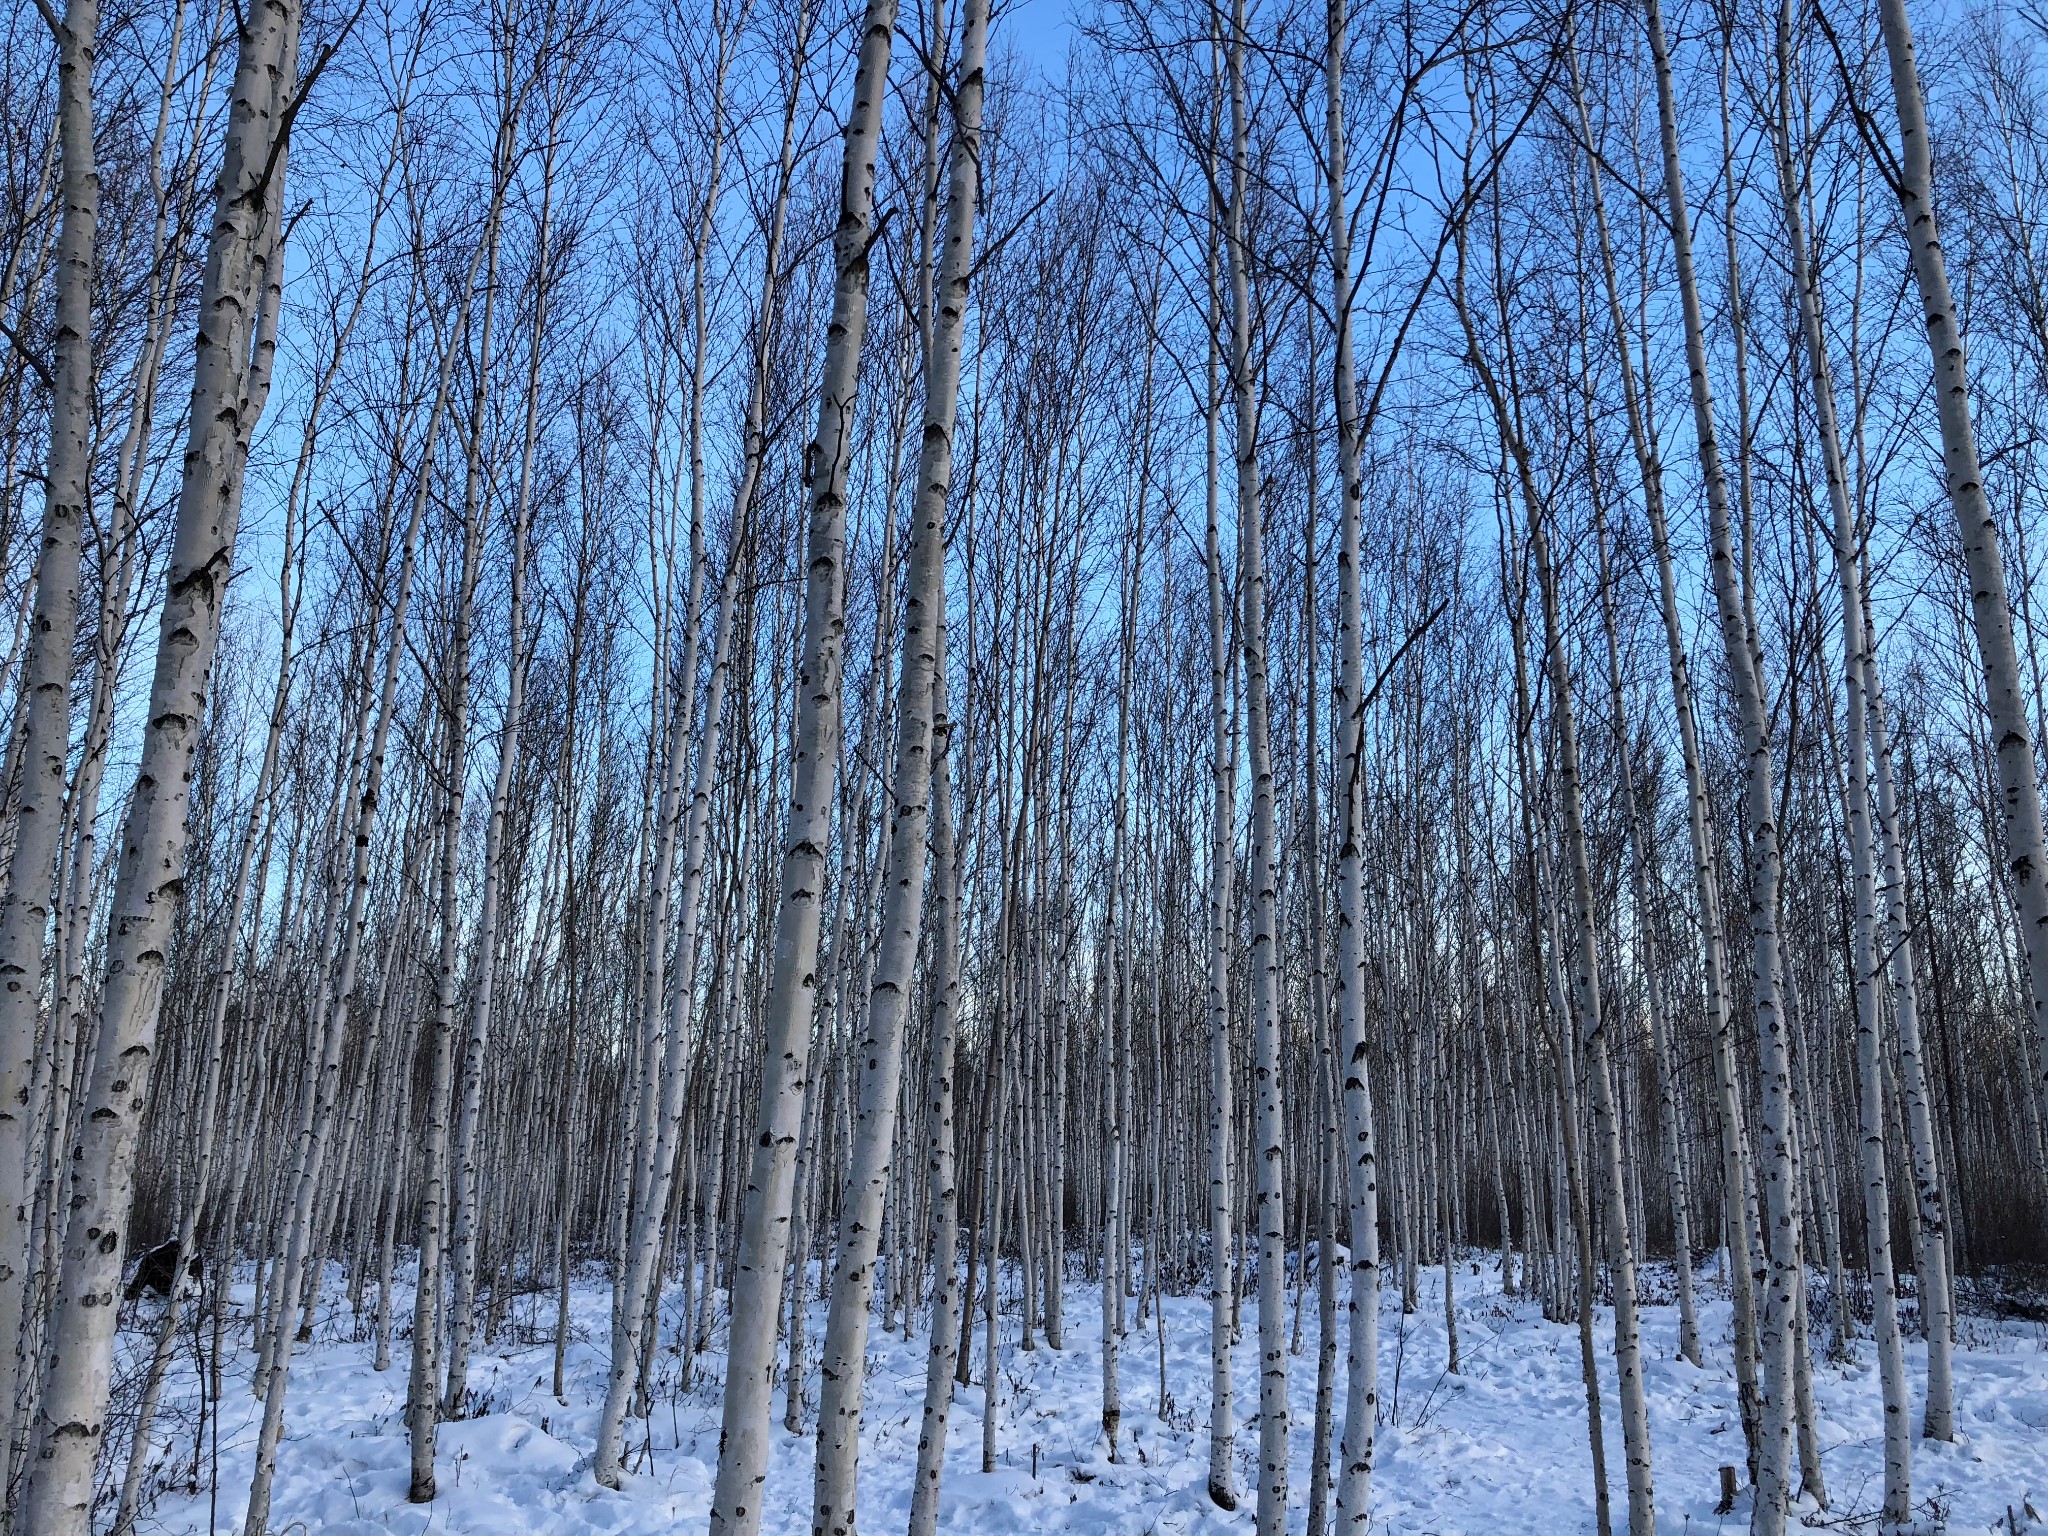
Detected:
left=125, top=1255, right=2048, bottom=1536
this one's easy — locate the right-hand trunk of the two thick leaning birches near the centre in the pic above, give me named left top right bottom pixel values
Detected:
left=811, top=0, right=989, bottom=1532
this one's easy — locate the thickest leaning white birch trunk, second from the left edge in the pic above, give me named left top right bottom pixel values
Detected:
left=23, top=0, right=299, bottom=1536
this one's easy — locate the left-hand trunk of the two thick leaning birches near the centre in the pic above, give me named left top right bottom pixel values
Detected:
left=711, top=0, right=897, bottom=1536
